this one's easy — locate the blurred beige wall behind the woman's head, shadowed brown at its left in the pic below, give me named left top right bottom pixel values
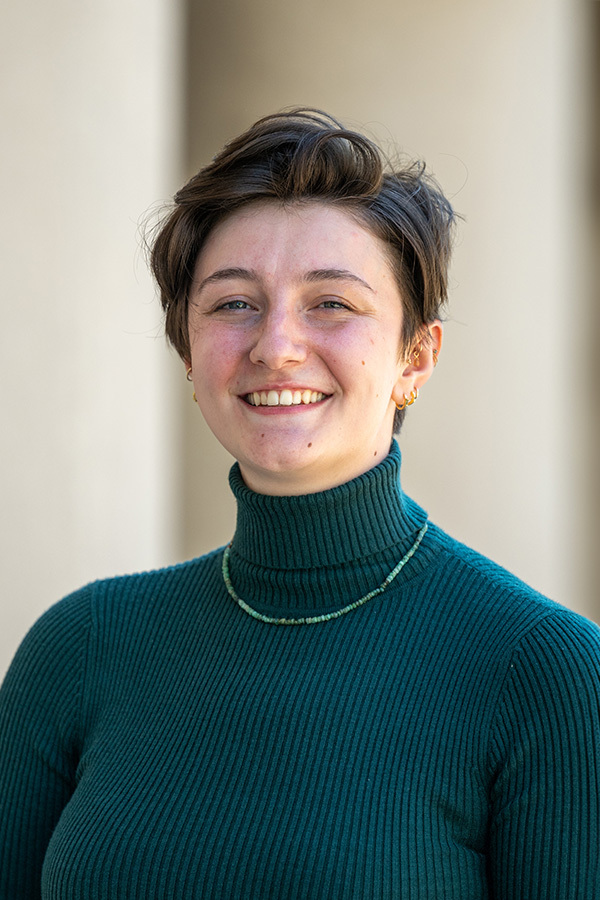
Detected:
left=185, top=0, right=600, bottom=617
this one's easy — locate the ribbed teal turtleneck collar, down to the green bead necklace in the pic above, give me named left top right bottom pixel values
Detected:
left=229, top=441, right=427, bottom=615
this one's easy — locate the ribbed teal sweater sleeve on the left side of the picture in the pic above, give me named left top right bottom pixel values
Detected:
left=0, top=591, right=89, bottom=900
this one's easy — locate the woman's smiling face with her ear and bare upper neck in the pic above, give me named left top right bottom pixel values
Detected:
left=189, top=202, right=432, bottom=495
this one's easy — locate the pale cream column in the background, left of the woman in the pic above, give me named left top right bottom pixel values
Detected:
left=0, top=0, right=181, bottom=672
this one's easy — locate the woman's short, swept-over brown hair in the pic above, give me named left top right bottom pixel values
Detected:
left=150, top=109, right=454, bottom=431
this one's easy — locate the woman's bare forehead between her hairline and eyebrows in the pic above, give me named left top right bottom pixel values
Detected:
left=195, top=201, right=393, bottom=280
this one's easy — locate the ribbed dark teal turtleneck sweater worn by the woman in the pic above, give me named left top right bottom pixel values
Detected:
left=0, top=445, right=600, bottom=900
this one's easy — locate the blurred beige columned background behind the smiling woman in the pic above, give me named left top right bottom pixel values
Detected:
left=0, top=0, right=600, bottom=672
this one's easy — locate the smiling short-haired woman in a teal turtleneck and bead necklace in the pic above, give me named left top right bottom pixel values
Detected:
left=0, top=111, right=600, bottom=900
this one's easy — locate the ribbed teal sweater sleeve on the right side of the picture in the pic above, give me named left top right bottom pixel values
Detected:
left=488, top=610, right=600, bottom=900
